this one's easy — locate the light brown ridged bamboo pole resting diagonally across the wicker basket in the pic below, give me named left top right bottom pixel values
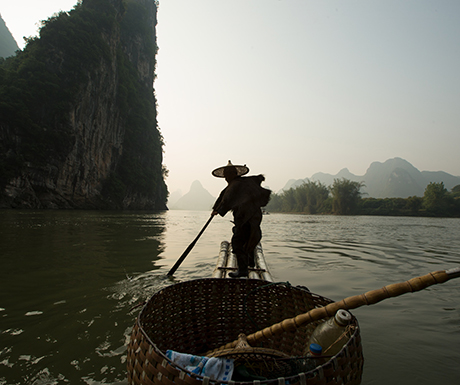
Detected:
left=207, top=267, right=460, bottom=355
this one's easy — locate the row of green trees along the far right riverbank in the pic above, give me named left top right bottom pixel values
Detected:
left=267, top=178, right=460, bottom=217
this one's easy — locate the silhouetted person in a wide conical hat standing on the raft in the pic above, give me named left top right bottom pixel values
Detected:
left=212, top=161, right=271, bottom=278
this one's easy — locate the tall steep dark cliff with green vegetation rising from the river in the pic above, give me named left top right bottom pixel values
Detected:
left=0, top=0, right=167, bottom=209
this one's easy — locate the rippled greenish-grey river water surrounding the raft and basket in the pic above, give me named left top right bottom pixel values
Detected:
left=0, top=210, right=460, bottom=385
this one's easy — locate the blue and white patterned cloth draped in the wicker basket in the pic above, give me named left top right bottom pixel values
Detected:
left=166, top=350, right=234, bottom=381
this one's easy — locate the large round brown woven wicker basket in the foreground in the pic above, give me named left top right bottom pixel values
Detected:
left=127, top=278, right=363, bottom=385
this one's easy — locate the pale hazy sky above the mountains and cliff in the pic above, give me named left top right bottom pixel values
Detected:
left=0, top=0, right=460, bottom=196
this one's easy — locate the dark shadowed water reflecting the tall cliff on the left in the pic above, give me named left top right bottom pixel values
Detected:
left=0, top=211, right=169, bottom=384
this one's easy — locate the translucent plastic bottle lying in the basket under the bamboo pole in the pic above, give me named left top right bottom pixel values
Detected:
left=308, top=309, right=352, bottom=356
